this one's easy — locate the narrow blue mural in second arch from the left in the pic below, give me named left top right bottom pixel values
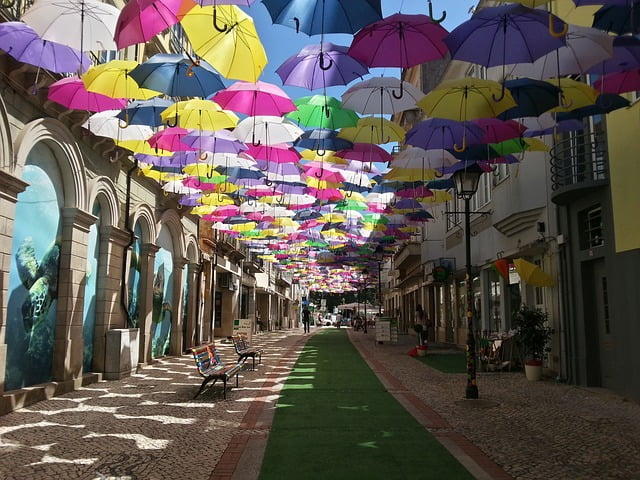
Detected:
left=82, top=203, right=100, bottom=372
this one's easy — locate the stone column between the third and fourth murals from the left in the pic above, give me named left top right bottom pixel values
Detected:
left=138, top=243, right=160, bottom=363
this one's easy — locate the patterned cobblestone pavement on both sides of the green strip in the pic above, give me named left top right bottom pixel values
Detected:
left=0, top=331, right=640, bottom=480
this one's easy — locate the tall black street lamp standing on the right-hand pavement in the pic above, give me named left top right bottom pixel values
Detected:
left=452, top=163, right=484, bottom=399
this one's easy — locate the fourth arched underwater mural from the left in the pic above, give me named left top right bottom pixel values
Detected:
left=151, top=227, right=174, bottom=358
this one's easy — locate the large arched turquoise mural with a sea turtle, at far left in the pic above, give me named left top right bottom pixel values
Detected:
left=5, top=143, right=63, bottom=390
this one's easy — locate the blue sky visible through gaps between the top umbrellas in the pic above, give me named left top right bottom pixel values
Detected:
left=244, top=0, right=477, bottom=99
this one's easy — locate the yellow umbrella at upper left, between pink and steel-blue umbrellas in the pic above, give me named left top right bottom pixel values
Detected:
left=81, top=60, right=160, bottom=100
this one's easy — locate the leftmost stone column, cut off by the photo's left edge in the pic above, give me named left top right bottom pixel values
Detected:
left=0, top=170, right=29, bottom=393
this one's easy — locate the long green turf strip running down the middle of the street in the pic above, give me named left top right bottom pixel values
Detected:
left=260, top=330, right=473, bottom=480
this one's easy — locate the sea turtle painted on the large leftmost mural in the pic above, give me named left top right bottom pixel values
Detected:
left=15, top=237, right=60, bottom=356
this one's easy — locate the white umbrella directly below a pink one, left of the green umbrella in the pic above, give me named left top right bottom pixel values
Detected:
left=233, top=115, right=304, bottom=145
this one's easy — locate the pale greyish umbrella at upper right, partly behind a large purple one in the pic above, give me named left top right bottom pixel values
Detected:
left=507, top=25, right=615, bottom=80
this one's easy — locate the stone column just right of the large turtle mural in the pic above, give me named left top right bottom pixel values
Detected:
left=52, top=208, right=97, bottom=382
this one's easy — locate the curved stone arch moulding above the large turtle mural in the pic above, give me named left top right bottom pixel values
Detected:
left=15, top=118, right=89, bottom=211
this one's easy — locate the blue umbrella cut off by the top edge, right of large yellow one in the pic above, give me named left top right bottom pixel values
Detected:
left=262, top=0, right=382, bottom=35
